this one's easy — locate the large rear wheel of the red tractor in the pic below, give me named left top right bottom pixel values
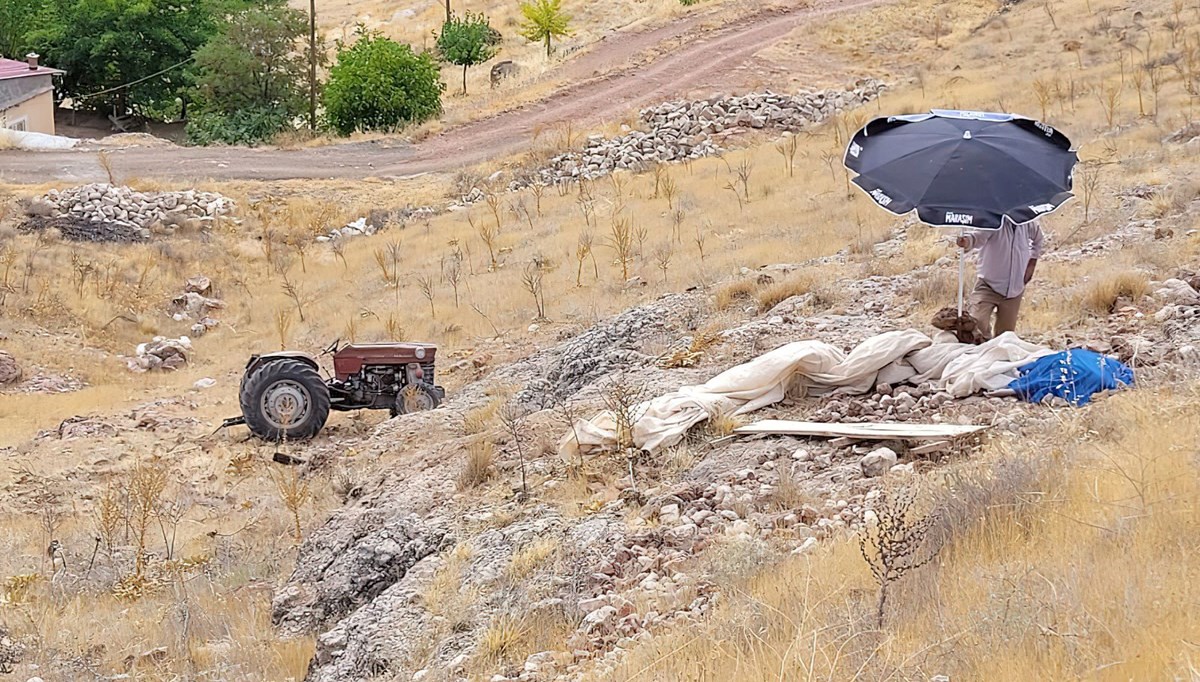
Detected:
left=239, top=359, right=329, bottom=441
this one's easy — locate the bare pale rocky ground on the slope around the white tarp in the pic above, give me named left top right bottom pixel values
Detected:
left=260, top=199, right=1200, bottom=682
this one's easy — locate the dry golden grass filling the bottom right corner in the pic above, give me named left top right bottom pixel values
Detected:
left=610, top=393, right=1200, bottom=681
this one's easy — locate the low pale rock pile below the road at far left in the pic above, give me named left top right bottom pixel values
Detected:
left=42, top=183, right=234, bottom=237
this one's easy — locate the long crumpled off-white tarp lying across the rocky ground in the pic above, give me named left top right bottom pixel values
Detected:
left=559, top=329, right=1054, bottom=457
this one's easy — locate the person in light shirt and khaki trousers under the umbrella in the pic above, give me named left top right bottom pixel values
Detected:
left=955, top=217, right=1042, bottom=339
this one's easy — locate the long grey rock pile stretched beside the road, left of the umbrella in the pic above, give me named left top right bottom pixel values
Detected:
left=532, top=79, right=883, bottom=184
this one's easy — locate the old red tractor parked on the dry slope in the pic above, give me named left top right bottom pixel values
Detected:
left=223, top=341, right=445, bottom=441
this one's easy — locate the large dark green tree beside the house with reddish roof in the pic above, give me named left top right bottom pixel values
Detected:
left=29, top=0, right=217, bottom=118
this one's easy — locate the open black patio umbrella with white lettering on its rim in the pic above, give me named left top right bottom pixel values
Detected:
left=845, top=109, right=1078, bottom=313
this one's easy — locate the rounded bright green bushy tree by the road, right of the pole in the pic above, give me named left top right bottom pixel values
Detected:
left=323, top=32, right=445, bottom=134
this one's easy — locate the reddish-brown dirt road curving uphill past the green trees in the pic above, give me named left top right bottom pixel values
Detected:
left=0, top=0, right=886, bottom=184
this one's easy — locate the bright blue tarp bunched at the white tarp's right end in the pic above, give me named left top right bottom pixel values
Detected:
left=1008, top=348, right=1133, bottom=406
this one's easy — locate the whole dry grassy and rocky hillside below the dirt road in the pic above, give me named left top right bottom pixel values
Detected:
left=0, top=0, right=1200, bottom=682
